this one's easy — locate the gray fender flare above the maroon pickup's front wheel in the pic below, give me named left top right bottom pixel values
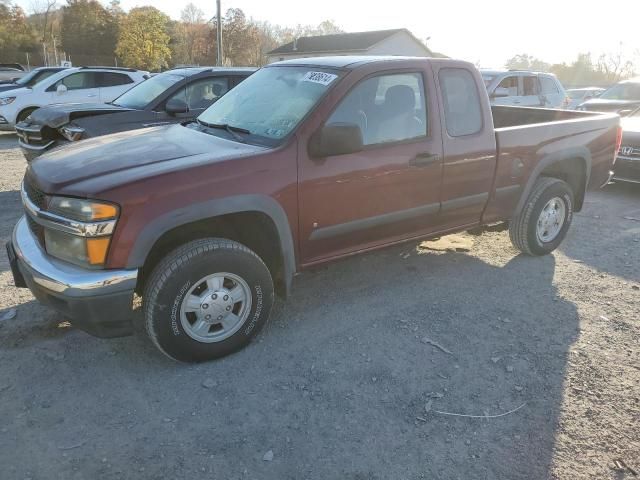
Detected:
left=127, top=195, right=296, bottom=294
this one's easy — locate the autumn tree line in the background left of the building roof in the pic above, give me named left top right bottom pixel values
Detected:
left=0, top=0, right=342, bottom=71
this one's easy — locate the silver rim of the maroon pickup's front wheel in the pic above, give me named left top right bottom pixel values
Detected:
left=180, top=272, right=251, bottom=343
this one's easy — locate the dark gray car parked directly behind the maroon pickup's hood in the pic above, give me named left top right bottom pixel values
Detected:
left=16, top=67, right=256, bottom=161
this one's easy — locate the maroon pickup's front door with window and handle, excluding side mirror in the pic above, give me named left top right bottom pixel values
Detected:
left=298, top=62, right=442, bottom=264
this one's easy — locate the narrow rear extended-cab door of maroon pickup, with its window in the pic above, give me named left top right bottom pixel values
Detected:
left=432, top=60, right=497, bottom=230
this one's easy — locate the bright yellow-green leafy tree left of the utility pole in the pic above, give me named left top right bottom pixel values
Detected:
left=116, top=7, right=171, bottom=70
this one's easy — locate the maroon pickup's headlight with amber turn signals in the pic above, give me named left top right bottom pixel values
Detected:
left=44, top=197, right=119, bottom=267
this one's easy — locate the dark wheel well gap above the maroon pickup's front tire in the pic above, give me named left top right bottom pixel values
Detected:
left=136, top=210, right=289, bottom=297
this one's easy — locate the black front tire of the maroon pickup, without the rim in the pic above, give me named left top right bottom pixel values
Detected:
left=143, top=238, right=274, bottom=362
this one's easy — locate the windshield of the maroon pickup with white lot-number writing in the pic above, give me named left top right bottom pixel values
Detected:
left=198, top=67, right=338, bottom=145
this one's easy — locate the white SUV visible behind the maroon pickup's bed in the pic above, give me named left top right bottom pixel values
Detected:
left=480, top=70, right=569, bottom=108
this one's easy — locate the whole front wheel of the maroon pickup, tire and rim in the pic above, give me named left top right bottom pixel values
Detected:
left=143, top=238, right=274, bottom=362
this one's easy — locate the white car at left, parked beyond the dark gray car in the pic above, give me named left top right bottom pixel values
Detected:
left=0, top=67, right=149, bottom=130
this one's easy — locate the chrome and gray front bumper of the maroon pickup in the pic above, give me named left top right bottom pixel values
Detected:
left=7, top=217, right=138, bottom=337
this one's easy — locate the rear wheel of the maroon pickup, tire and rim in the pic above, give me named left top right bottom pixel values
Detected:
left=509, top=177, right=573, bottom=255
